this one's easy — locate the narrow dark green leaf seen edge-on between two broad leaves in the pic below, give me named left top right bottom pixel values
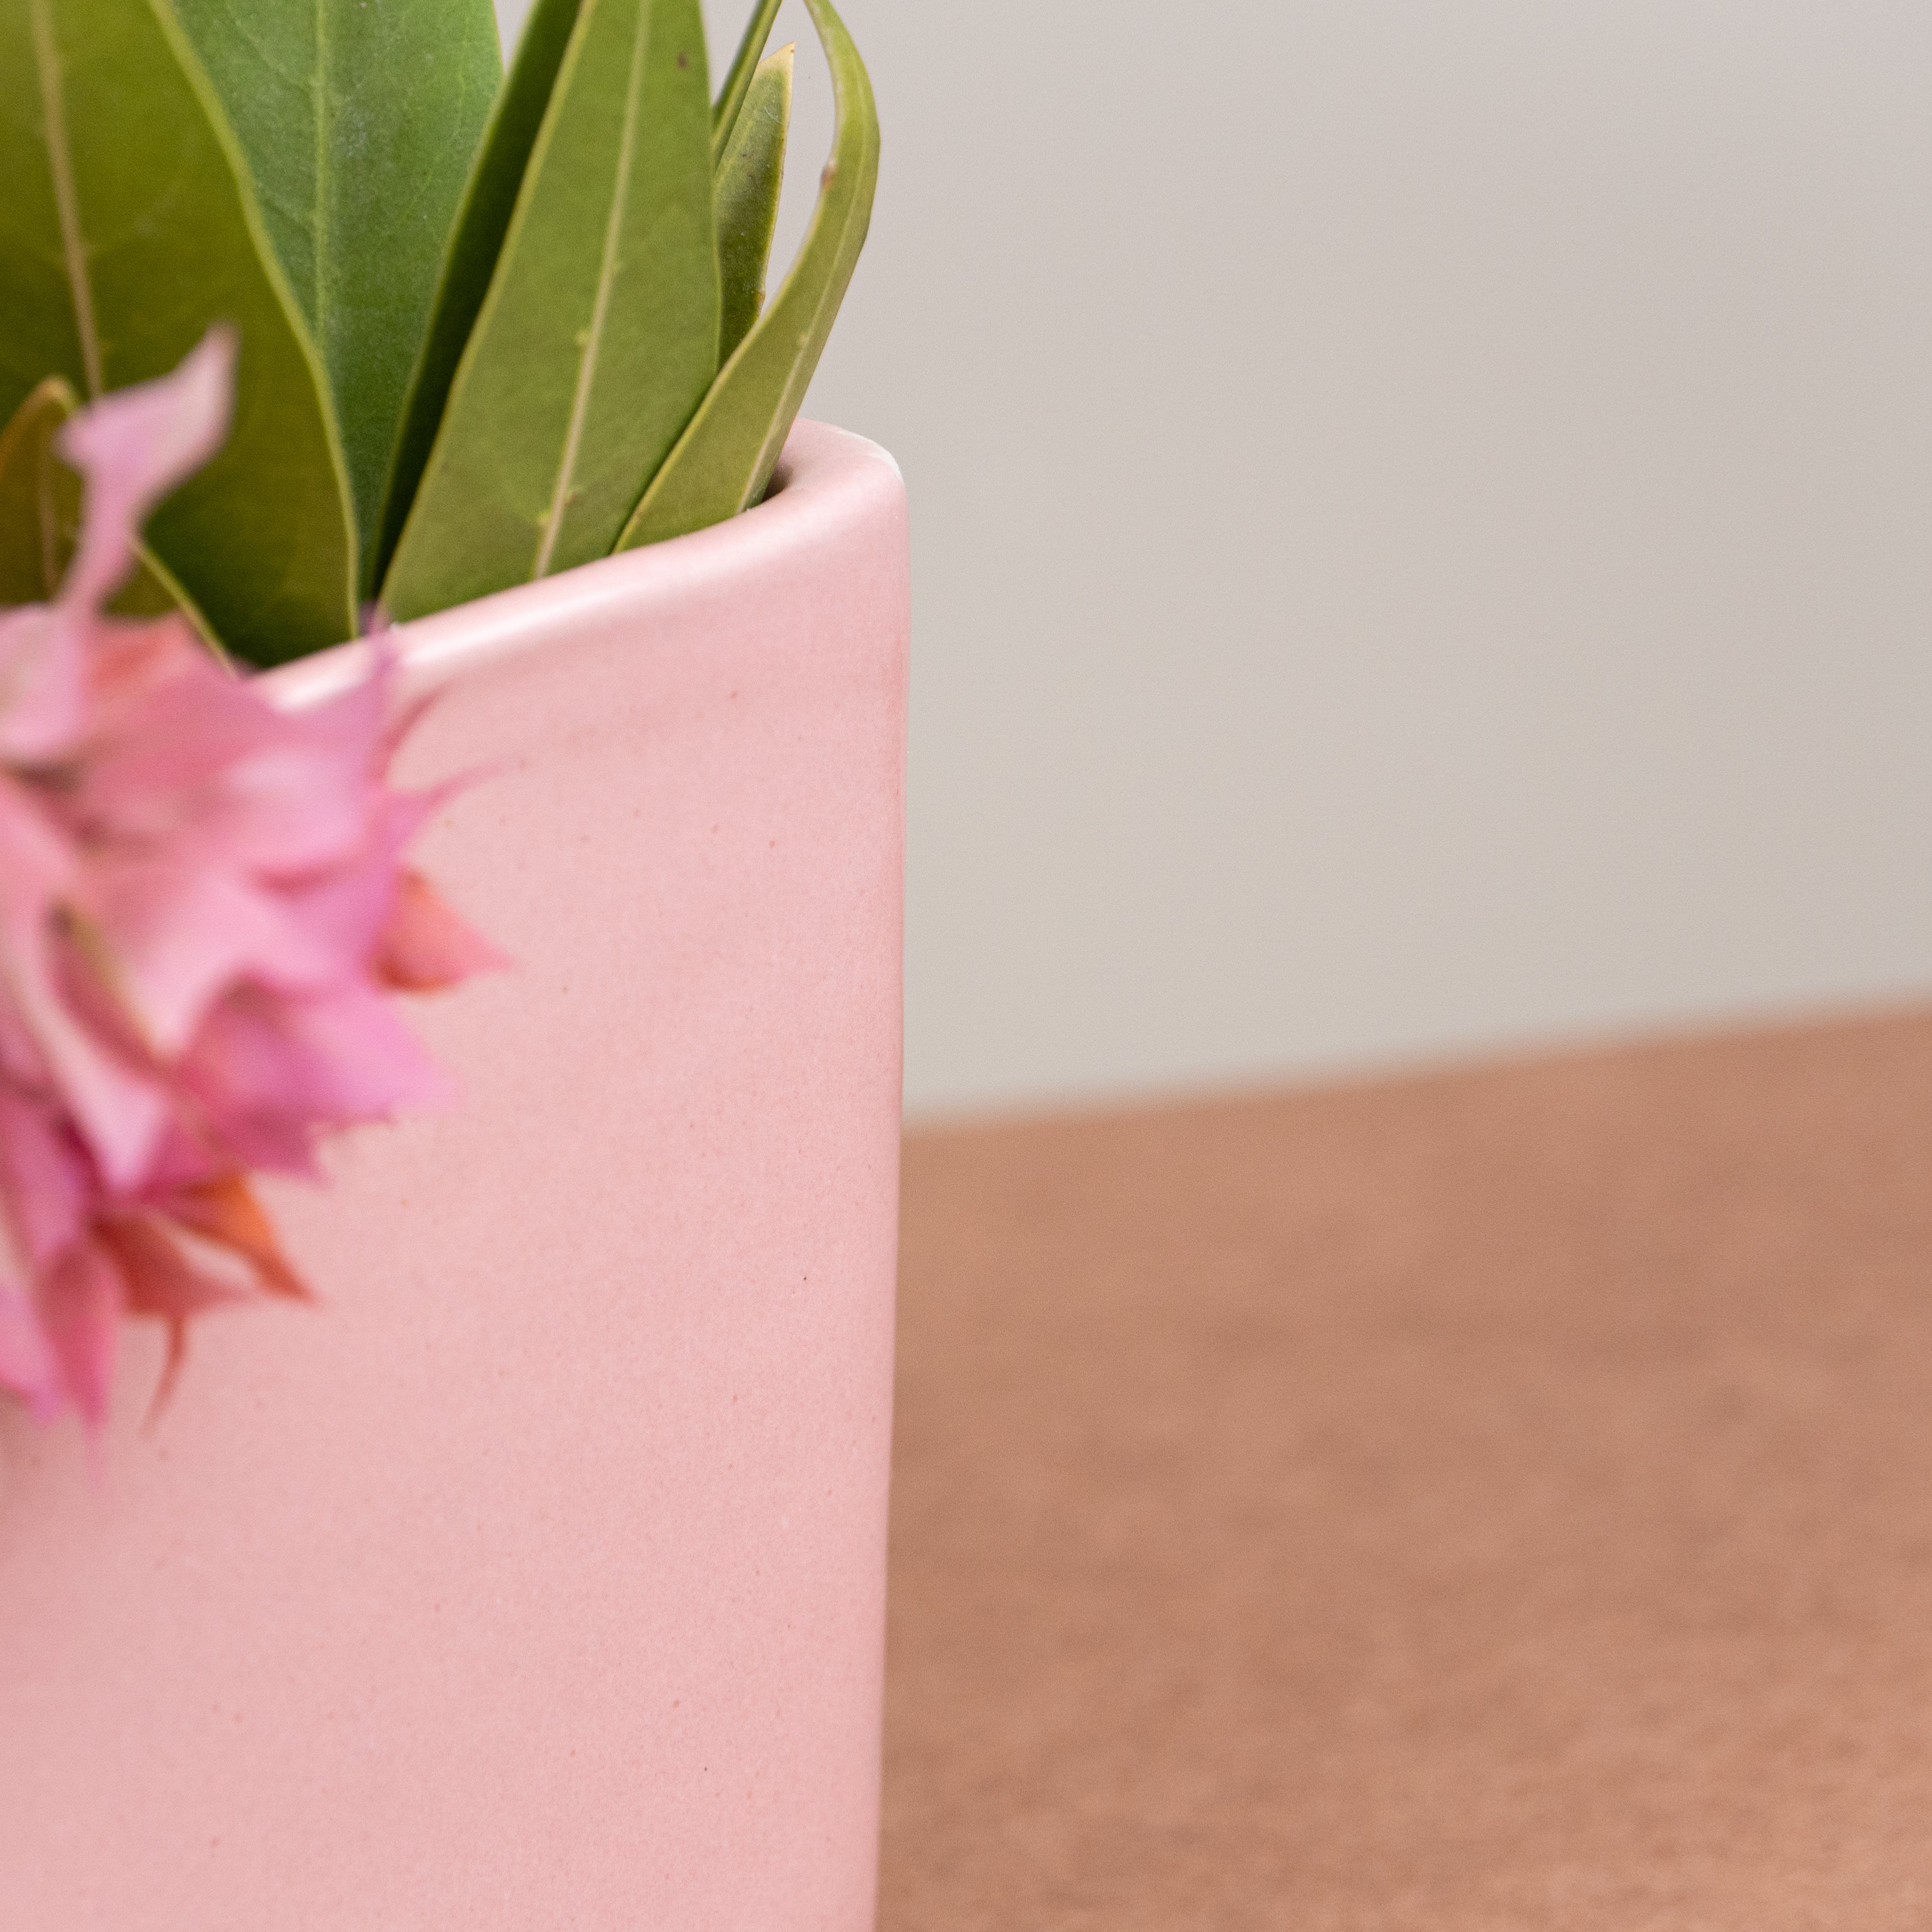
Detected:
left=365, top=0, right=580, bottom=585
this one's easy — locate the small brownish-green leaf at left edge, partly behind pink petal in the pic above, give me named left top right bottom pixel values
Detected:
left=0, top=375, right=215, bottom=645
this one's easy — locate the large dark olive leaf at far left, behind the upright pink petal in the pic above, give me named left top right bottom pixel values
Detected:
left=0, top=0, right=356, bottom=663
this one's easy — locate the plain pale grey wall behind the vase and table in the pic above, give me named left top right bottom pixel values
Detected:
left=498, top=0, right=1932, bottom=1111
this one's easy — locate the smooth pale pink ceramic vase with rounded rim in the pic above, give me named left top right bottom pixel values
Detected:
left=0, top=423, right=908, bottom=1932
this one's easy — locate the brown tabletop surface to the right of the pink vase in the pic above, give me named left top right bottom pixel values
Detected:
left=881, top=1016, right=1932, bottom=1932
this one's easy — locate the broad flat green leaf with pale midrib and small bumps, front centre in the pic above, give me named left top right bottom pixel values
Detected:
left=383, top=0, right=719, bottom=618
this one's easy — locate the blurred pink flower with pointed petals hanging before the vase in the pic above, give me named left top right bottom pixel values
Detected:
left=0, top=334, right=497, bottom=1428
